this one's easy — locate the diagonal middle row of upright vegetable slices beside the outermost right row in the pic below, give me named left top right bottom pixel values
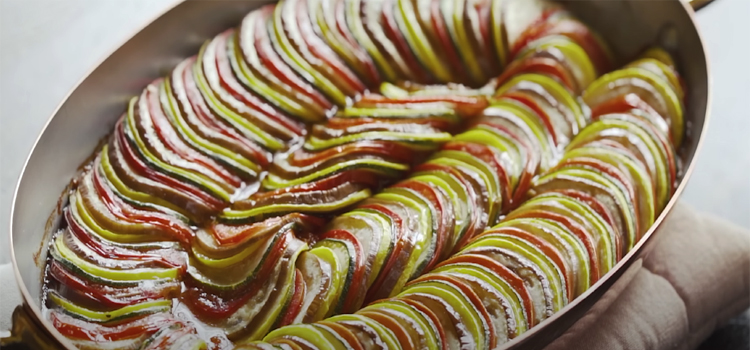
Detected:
left=266, top=67, right=604, bottom=323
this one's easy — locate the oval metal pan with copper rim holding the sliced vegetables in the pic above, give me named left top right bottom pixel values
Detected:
left=0, top=0, right=710, bottom=349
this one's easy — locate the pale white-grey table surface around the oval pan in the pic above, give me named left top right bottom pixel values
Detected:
left=0, top=0, right=750, bottom=264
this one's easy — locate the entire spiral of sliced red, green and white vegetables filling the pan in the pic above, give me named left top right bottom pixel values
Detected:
left=38, top=0, right=684, bottom=349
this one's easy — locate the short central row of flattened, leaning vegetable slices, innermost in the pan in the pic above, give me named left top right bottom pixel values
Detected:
left=220, top=93, right=487, bottom=223
